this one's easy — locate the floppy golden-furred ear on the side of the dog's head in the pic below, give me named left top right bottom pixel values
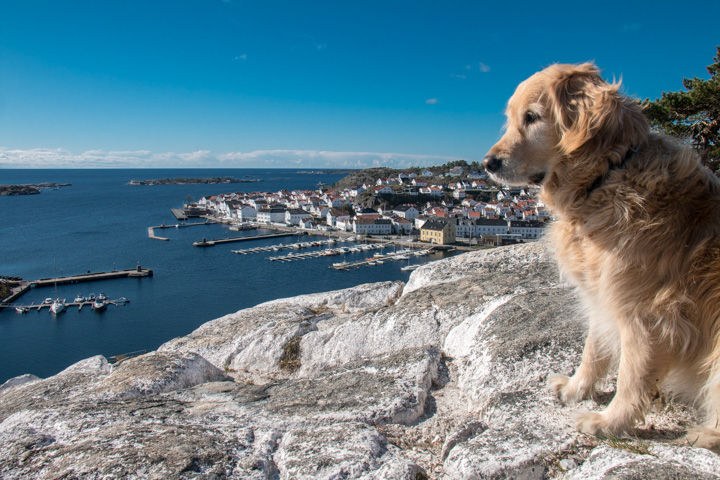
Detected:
left=548, top=63, right=649, bottom=161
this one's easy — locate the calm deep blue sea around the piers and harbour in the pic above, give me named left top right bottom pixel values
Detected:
left=0, top=169, right=450, bottom=383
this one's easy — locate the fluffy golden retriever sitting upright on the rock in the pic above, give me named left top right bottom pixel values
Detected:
left=483, top=64, right=720, bottom=451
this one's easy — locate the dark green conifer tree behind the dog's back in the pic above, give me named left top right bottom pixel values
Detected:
left=643, top=46, right=720, bottom=174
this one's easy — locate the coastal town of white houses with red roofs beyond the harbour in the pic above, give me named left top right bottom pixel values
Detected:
left=183, top=162, right=551, bottom=246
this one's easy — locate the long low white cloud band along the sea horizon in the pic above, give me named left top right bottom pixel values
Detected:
left=0, top=147, right=457, bottom=168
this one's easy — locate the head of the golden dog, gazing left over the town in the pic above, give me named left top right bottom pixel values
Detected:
left=482, top=63, right=648, bottom=189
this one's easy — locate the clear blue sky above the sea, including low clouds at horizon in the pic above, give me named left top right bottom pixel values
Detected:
left=0, top=0, right=720, bottom=168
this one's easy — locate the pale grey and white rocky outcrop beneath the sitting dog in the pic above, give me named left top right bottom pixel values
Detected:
left=0, top=245, right=720, bottom=479
